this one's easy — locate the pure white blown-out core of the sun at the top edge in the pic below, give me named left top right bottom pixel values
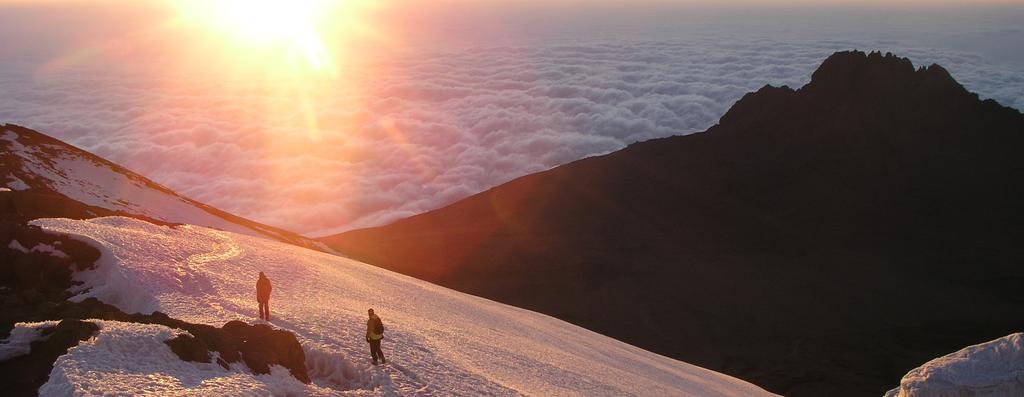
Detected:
left=177, top=0, right=339, bottom=70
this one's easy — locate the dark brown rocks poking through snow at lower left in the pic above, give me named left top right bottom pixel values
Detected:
left=0, top=219, right=310, bottom=395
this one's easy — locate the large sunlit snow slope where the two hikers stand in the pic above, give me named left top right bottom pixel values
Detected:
left=33, top=217, right=771, bottom=396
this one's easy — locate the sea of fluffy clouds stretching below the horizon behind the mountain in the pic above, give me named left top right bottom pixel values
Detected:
left=0, top=5, right=1024, bottom=235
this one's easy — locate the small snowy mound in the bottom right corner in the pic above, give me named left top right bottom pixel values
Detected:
left=886, top=333, right=1024, bottom=397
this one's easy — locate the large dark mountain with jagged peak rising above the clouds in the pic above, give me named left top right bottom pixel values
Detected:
left=323, top=51, right=1024, bottom=396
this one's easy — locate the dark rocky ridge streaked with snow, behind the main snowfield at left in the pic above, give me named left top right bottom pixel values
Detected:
left=0, top=125, right=323, bottom=249
